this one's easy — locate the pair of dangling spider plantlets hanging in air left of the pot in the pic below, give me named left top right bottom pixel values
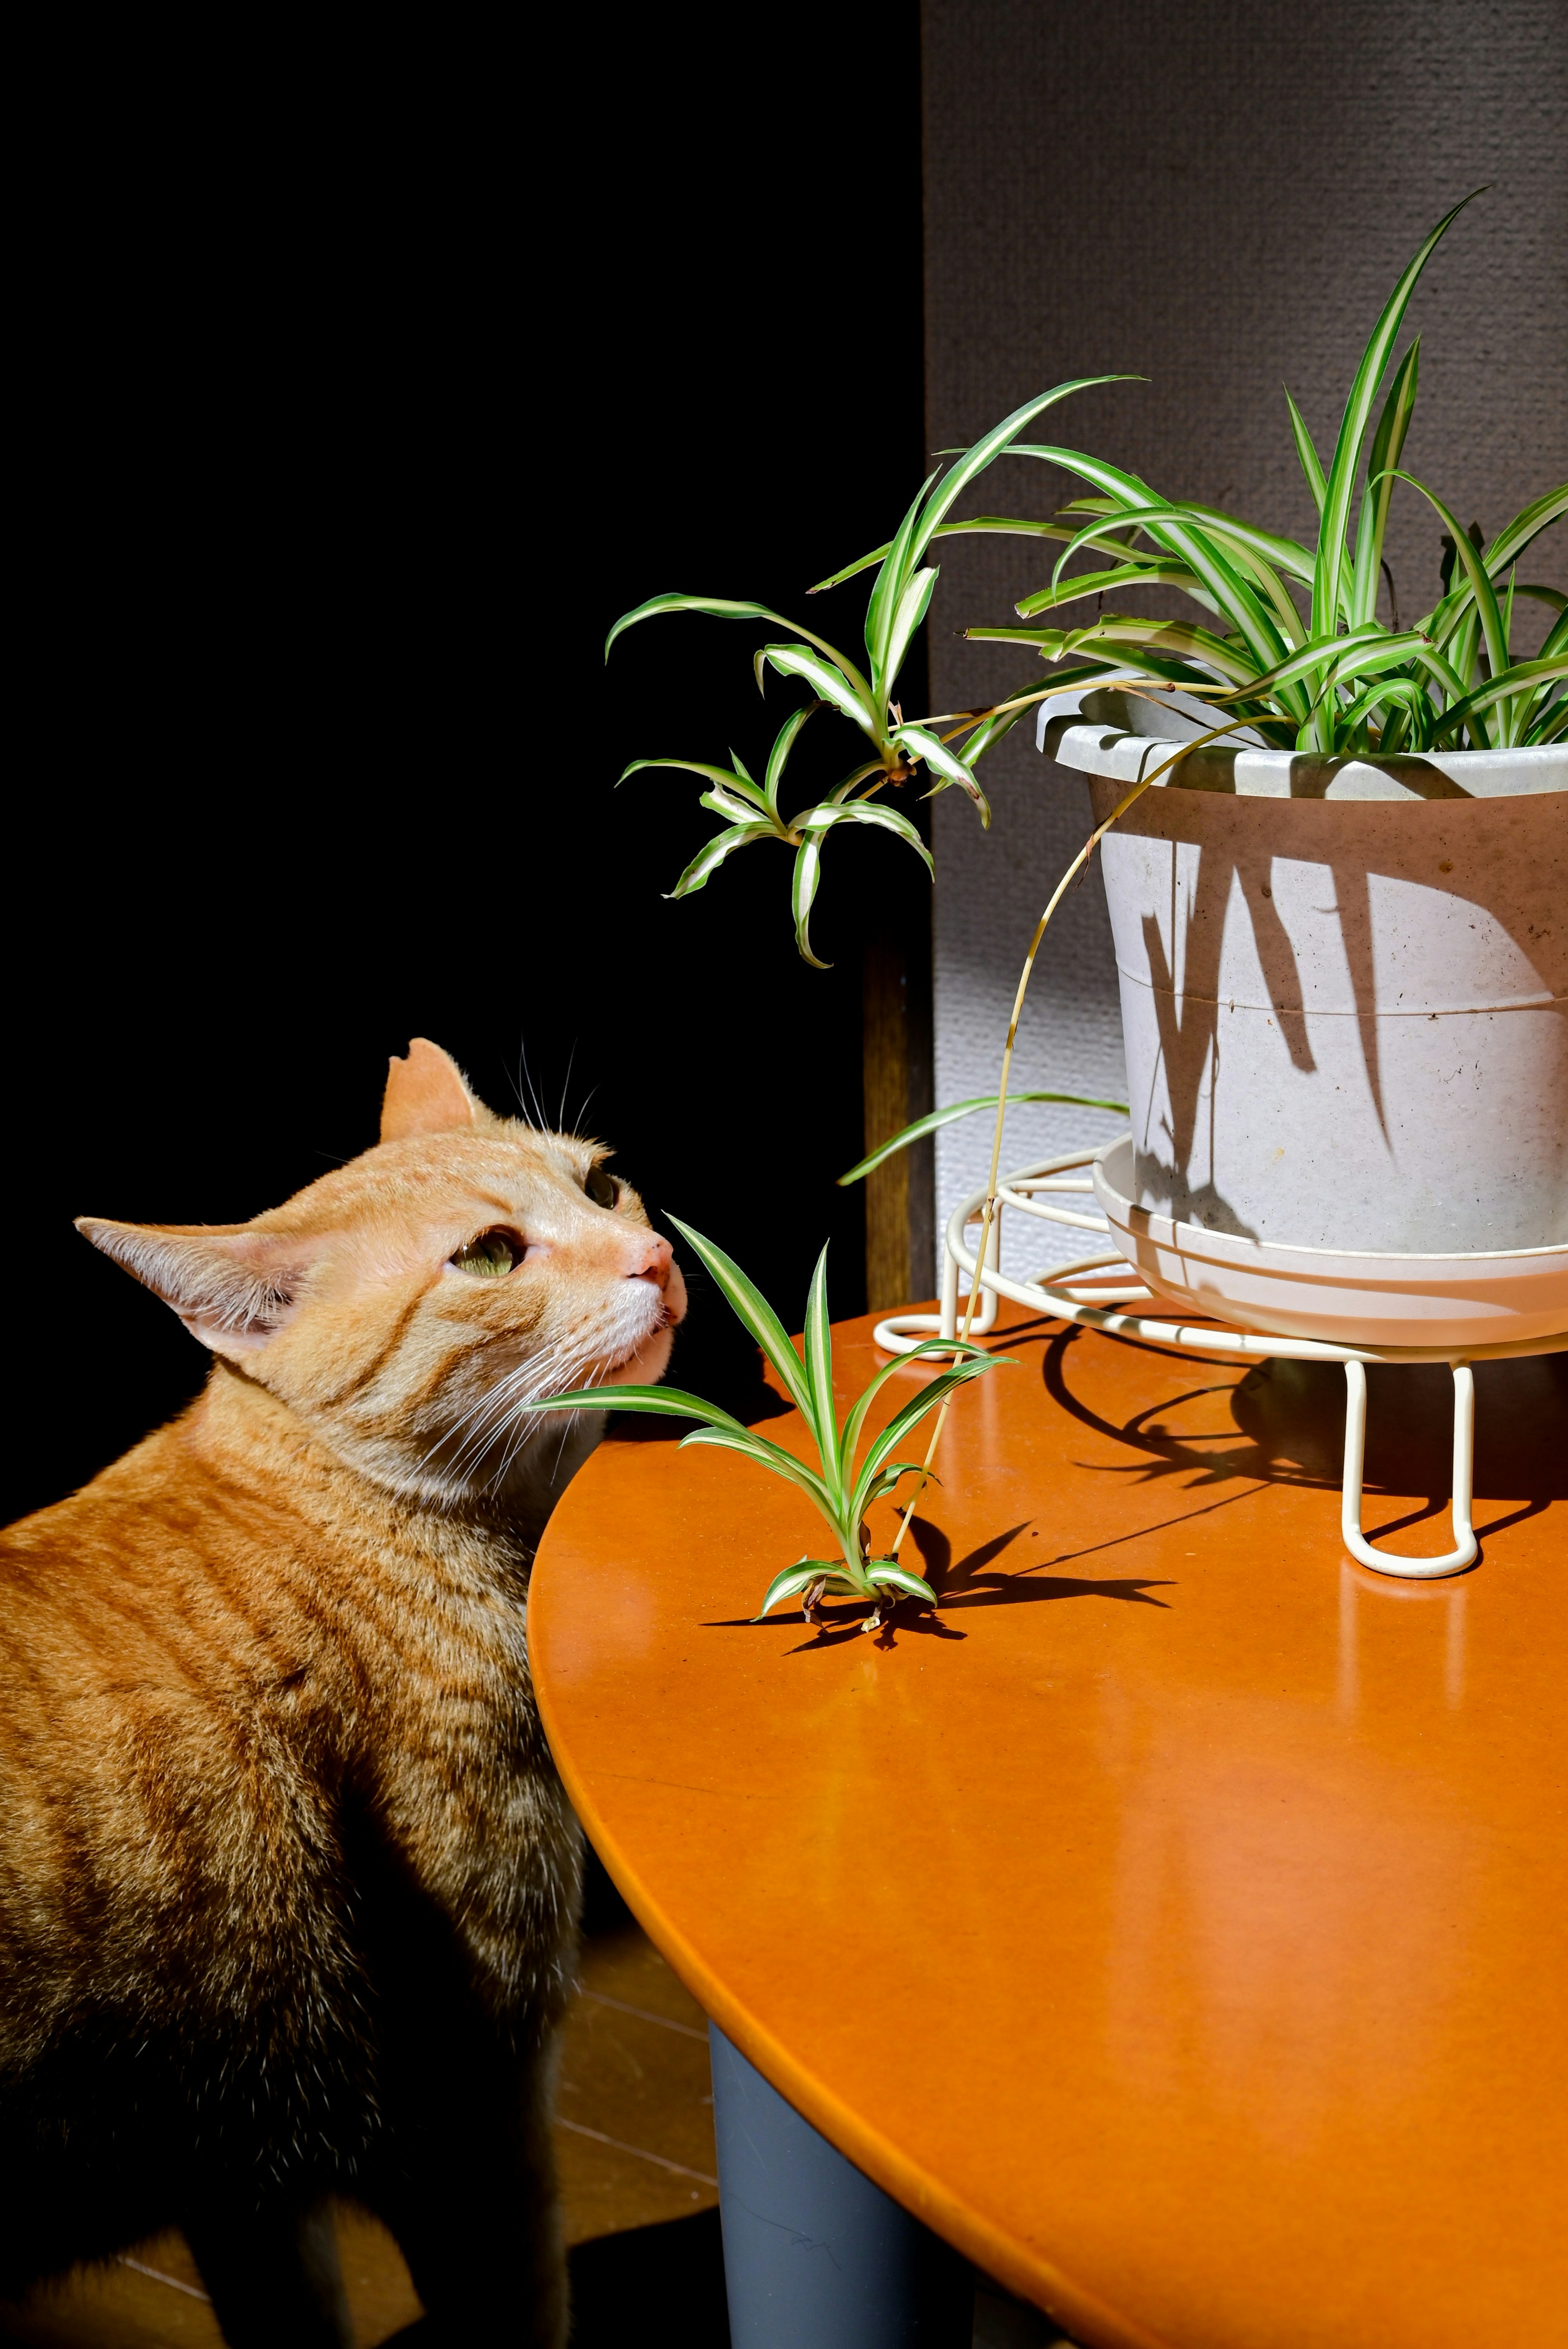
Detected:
left=603, top=376, right=1122, bottom=970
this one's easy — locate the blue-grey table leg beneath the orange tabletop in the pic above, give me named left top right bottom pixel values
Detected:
left=709, top=2025, right=974, bottom=2349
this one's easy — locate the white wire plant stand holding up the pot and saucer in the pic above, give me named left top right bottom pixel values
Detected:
left=873, top=1144, right=1568, bottom=1581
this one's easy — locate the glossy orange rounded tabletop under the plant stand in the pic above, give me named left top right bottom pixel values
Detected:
left=530, top=1320, right=1568, bottom=2349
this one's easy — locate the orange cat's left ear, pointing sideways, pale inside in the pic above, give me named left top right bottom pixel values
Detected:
left=75, top=1214, right=314, bottom=1363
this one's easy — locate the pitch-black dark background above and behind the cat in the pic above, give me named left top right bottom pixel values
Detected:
left=2, top=5, right=925, bottom=1515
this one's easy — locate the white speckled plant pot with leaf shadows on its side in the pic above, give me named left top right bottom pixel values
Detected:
left=1040, top=693, right=1568, bottom=1287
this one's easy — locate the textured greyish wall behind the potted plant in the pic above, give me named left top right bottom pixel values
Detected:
left=922, top=0, right=1568, bottom=1269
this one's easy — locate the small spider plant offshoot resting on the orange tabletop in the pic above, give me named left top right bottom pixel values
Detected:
left=533, top=1217, right=1007, bottom=1630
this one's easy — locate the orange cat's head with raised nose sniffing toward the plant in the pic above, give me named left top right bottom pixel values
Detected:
left=78, top=1036, right=686, bottom=1501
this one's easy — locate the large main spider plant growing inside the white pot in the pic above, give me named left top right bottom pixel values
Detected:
left=943, top=190, right=1568, bottom=756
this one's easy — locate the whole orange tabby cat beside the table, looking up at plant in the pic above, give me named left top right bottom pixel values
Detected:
left=0, top=1038, right=686, bottom=2349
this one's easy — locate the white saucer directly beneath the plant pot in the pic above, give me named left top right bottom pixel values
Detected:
left=1094, top=1135, right=1568, bottom=1353
